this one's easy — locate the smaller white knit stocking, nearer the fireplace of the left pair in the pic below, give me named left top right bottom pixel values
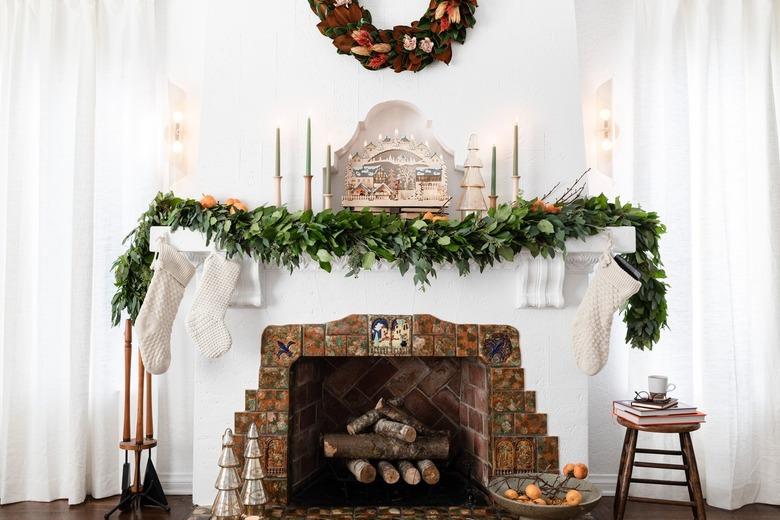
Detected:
left=187, top=253, right=241, bottom=358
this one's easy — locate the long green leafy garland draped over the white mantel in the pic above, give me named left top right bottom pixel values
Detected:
left=111, top=193, right=667, bottom=350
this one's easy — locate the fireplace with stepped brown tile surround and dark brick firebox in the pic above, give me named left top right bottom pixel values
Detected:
left=229, top=315, right=558, bottom=507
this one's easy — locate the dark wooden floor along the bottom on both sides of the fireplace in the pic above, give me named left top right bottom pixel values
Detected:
left=0, top=496, right=780, bottom=520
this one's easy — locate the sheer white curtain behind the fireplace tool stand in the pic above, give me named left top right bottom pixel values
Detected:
left=0, top=0, right=162, bottom=503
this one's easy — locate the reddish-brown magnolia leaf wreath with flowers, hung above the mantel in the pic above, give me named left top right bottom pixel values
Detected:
left=309, top=0, right=477, bottom=72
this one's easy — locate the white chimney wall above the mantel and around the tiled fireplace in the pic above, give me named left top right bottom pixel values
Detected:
left=152, top=0, right=632, bottom=503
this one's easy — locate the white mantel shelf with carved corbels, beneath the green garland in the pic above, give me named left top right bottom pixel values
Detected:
left=149, top=226, right=636, bottom=309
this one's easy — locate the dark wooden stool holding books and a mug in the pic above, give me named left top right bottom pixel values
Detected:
left=612, top=417, right=707, bottom=520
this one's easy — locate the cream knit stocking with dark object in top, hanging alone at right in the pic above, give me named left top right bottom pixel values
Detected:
left=573, top=255, right=642, bottom=376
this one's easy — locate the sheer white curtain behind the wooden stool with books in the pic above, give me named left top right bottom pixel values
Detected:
left=628, top=0, right=780, bottom=509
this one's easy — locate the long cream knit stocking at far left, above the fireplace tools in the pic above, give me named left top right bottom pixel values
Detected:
left=135, top=241, right=195, bottom=374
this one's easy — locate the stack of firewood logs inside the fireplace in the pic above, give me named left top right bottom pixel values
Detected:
left=322, top=399, right=450, bottom=485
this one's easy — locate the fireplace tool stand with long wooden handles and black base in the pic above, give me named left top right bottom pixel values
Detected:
left=103, top=320, right=171, bottom=518
